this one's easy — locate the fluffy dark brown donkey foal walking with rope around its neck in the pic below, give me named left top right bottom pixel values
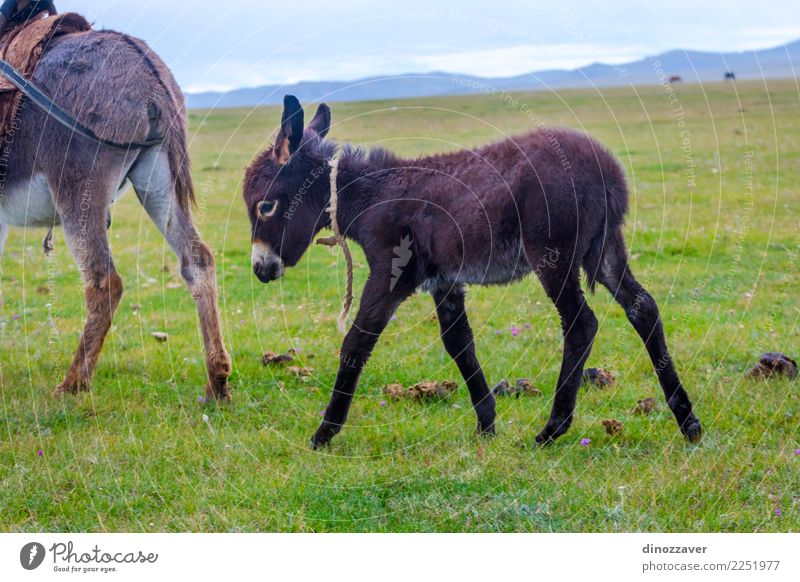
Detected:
left=244, top=96, right=702, bottom=448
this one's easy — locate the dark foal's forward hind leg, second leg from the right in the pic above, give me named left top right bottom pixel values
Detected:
left=536, top=265, right=597, bottom=444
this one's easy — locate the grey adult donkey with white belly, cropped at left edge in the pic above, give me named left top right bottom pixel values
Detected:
left=0, top=20, right=231, bottom=399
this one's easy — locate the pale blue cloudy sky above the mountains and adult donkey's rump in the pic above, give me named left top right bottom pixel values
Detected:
left=56, top=0, right=800, bottom=91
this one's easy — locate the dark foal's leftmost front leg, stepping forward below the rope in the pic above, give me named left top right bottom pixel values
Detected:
left=311, top=269, right=416, bottom=449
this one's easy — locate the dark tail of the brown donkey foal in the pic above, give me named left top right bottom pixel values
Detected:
left=581, top=152, right=628, bottom=293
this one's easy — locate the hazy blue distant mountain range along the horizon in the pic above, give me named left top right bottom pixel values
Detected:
left=186, top=40, right=800, bottom=109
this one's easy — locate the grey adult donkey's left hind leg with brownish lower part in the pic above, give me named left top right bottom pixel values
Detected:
left=55, top=182, right=122, bottom=395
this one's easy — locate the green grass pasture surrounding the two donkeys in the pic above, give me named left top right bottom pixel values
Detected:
left=0, top=81, right=800, bottom=532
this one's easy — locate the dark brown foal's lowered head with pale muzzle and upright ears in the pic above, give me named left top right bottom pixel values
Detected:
left=244, top=95, right=332, bottom=283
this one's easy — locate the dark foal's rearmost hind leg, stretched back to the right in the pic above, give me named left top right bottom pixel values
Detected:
left=598, top=234, right=703, bottom=442
